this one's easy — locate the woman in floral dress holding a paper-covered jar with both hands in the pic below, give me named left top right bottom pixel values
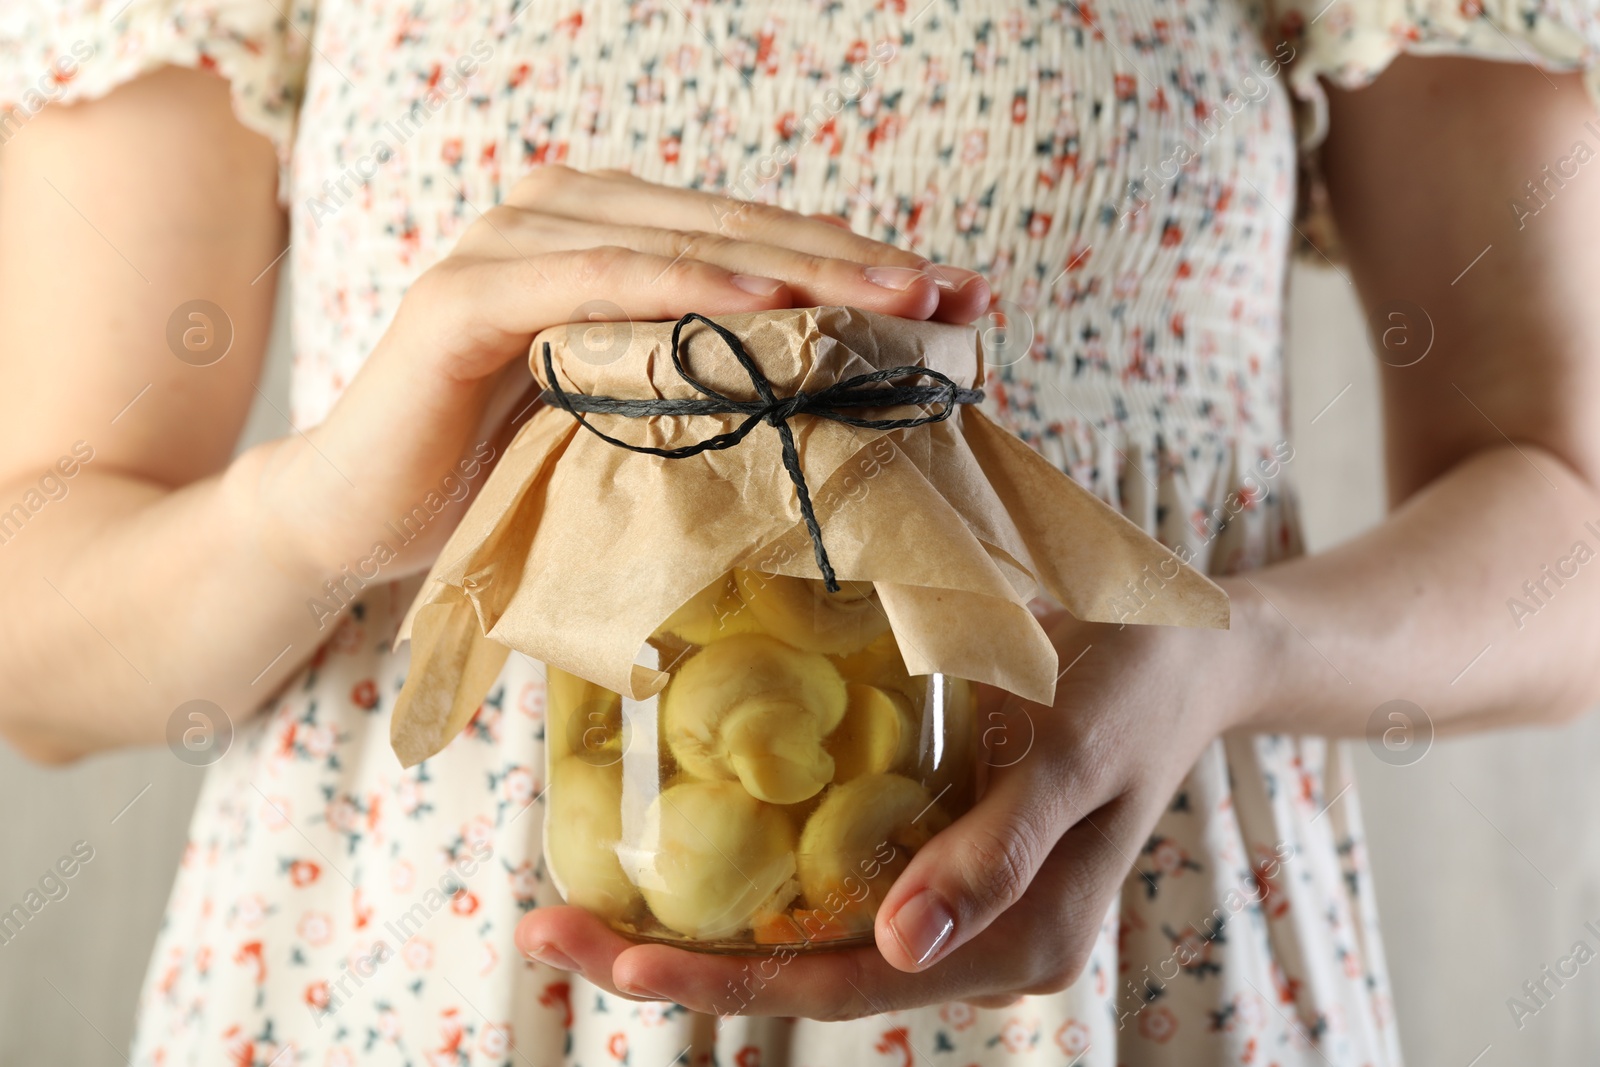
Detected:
left=0, top=0, right=1600, bottom=1067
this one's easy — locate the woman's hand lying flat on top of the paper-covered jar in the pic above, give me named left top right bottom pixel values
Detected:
left=251, top=166, right=989, bottom=581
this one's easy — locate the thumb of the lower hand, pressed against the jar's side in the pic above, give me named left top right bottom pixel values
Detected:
left=875, top=701, right=1098, bottom=971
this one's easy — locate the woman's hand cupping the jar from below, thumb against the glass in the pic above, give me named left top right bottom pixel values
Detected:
left=517, top=614, right=1238, bottom=1021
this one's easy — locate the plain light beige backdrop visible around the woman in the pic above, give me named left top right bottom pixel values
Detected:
left=0, top=267, right=1600, bottom=1067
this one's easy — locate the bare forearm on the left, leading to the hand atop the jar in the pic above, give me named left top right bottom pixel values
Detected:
left=0, top=440, right=336, bottom=760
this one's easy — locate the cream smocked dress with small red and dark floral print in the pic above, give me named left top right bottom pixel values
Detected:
left=9, top=0, right=1600, bottom=1067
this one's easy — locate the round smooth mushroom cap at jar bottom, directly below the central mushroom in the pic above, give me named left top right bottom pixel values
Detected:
left=624, top=781, right=800, bottom=941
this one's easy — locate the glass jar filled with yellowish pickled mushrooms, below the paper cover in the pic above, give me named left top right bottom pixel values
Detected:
left=544, top=569, right=978, bottom=952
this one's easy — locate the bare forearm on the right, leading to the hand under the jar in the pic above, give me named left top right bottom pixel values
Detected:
left=1198, top=445, right=1600, bottom=734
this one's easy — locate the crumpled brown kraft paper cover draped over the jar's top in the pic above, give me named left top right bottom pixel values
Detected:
left=390, top=307, right=1229, bottom=766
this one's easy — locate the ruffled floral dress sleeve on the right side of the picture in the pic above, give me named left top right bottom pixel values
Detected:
left=1274, top=0, right=1600, bottom=258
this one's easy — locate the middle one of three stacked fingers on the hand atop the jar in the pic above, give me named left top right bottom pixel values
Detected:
left=470, top=210, right=941, bottom=318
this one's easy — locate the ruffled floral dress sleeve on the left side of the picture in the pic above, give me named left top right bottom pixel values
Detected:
left=0, top=0, right=315, bottom=203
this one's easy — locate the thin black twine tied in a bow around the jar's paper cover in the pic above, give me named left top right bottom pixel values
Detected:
left=544, top=312, right=984, bottom=593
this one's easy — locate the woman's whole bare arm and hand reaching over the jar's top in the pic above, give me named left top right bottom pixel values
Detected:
left=0, top=93, right=989, bottom=761
